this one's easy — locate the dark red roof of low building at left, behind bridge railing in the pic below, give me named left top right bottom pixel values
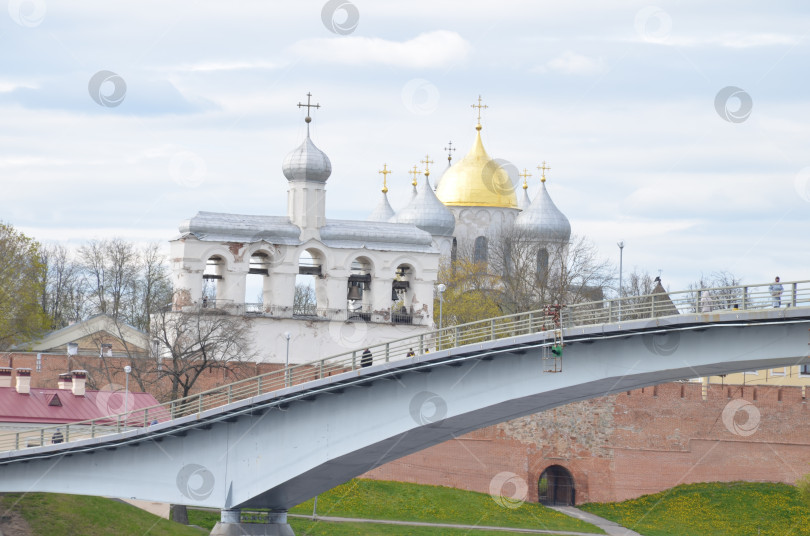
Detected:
left=0, top=387, right=169, bottom=425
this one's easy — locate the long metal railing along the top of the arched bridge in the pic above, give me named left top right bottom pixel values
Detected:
left=0, top=280, right=810, bottom=451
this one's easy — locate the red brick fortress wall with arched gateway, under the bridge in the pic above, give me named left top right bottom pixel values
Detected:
left=363, top=383, right=810, bottom=504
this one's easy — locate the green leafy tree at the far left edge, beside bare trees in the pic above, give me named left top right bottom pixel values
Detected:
left=0, top=222, right=48, bottom=349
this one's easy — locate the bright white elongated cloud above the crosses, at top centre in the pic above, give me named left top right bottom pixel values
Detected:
left=290, top=30, right=472, bottom=69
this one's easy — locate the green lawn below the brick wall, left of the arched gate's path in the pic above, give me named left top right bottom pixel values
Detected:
left=189, top=479, right=604, bottom=534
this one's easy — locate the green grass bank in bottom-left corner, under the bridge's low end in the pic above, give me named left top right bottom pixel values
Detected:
left=0, top=493, right=202, bottom=536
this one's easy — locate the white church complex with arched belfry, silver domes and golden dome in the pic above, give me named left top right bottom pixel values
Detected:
left=170, top=95, right=571, bottom=363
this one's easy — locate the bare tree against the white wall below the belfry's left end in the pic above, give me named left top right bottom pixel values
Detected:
left=150, top=308, right=256, bottom=399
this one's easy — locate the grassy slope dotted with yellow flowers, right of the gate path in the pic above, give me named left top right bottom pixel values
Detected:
left=580, top=482, right=810, bottom=536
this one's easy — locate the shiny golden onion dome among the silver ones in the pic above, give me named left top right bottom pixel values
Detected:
left=436, top=126, right=518, bottom=208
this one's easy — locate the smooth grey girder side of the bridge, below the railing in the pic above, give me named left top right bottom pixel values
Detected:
left=0, top=310, right=810, bottom=511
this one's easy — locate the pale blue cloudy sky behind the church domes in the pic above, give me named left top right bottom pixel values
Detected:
left=0, top=0, right=810, bottom=290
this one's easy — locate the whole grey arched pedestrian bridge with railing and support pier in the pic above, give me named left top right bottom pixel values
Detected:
left=0, top=281, right=810, bottom=534
